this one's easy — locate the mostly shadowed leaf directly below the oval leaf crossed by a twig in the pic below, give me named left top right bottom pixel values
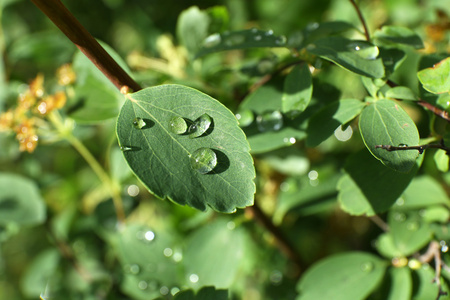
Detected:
left=338, top=150, right=420, bottom=216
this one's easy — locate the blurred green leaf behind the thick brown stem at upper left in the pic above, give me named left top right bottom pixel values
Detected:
left=68, top=43, right=131, bottom=123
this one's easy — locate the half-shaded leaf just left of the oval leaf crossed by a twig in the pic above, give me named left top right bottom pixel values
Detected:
left=306, top=99, right=365, bottom=147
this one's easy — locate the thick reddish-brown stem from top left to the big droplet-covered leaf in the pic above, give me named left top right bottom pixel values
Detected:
left=31, top=0, right=141, bottom=91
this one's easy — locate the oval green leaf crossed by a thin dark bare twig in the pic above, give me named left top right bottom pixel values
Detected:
left=359, top=99, right=419, bottom=173
